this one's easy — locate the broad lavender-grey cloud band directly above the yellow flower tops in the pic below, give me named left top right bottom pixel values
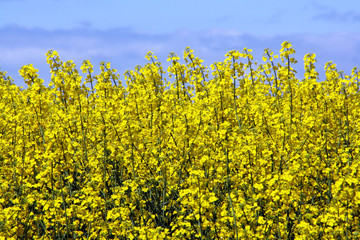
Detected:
left=0, top=26, right=360, bottom=86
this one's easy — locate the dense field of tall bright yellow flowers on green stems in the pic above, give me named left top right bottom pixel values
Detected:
left=0, top=42, right=360, bottom=239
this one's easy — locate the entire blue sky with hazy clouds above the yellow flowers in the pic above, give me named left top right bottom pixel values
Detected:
left=0, top=0, right=360, bottom=86
